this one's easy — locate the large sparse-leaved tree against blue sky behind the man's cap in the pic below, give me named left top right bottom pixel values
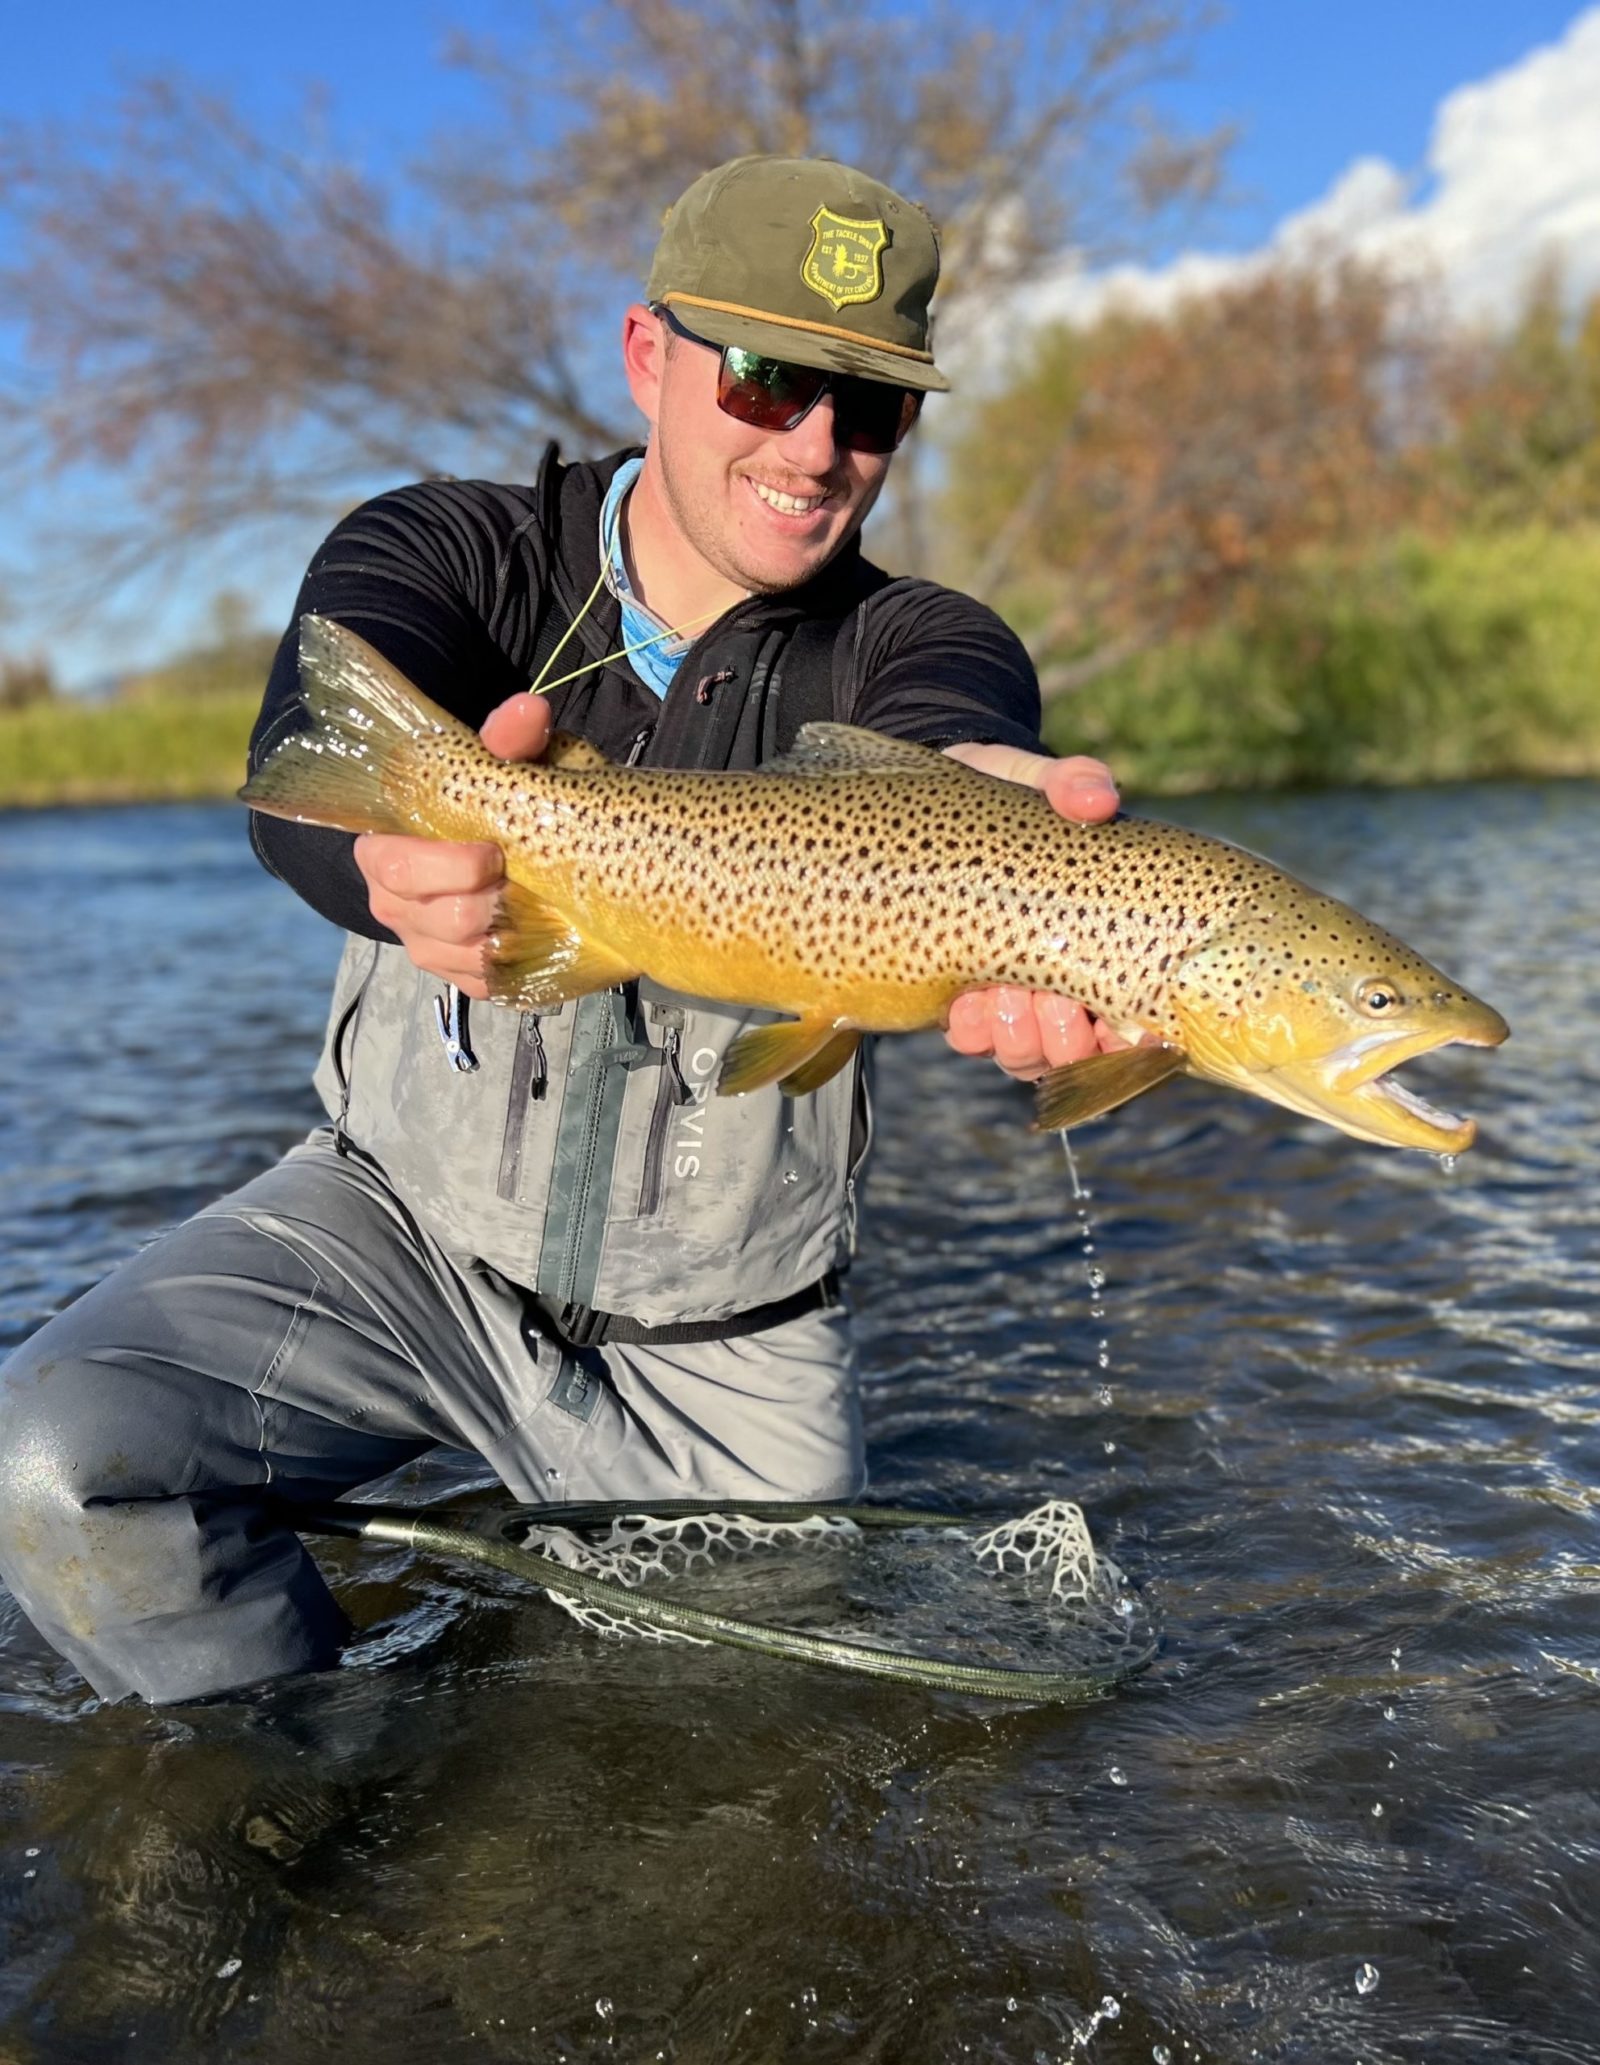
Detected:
left=0, top=0, right=1222, bottom=602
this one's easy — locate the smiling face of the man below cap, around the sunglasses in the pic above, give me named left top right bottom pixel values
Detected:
left=628, top=308, right=894, bottom=595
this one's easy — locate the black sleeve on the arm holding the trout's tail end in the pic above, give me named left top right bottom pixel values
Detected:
left=250, top=481, right=533, bottom=942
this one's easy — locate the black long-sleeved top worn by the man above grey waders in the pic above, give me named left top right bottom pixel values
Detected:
left=250, top=452, right=1041, bottom=940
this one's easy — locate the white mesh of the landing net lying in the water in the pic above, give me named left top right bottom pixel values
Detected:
left=520, top=1499, right=1154, bottom=1669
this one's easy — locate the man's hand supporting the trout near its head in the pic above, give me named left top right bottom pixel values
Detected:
left=946, top=745, right=1127, bottom=1082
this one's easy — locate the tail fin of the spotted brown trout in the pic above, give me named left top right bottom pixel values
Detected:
left=239, top=615, right=483, bottom=832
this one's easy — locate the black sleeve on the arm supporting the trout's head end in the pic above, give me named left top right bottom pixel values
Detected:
left=851, top=580, right=1045, bottom=754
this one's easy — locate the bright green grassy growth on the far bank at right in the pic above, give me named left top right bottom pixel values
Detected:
left=1045, top=529, right=1600, bottom=793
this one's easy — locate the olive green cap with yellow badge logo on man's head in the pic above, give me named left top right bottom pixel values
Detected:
left=644, top=157, right=950, bottom=394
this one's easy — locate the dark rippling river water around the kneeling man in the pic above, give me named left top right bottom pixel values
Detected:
left=0, top=785, right=1600, bottom=2065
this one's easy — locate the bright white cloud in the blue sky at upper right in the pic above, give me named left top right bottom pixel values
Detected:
left=1018, top=6, right=1600, bottom=342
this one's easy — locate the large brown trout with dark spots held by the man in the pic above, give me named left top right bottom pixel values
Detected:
left=239, top=617, right=1507, bottom=1154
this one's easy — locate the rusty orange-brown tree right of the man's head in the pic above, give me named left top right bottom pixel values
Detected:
left=950, top=260, right=1437, bottom=688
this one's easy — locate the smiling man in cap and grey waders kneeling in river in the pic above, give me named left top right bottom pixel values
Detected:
left=0, top=157, right=1115, bottom=1702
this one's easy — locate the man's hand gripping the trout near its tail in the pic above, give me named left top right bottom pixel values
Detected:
left=355, top=694, right=549, bottom=997
